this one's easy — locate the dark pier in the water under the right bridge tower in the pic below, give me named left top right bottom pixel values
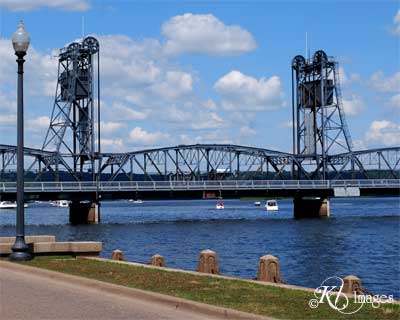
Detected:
left=293, top=197, right=330, bottom=219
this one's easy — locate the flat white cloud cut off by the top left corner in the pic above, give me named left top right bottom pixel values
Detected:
left=0, top=0, right=90, bottom=11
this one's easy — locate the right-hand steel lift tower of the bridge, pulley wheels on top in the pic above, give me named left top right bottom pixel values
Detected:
left=292, top=50, right=352, bottom=180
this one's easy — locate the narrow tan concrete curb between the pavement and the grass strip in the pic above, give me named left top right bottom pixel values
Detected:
left=0, top=261, right=275, bottom=320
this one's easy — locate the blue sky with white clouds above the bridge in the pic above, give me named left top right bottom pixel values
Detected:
left=0, top=0, right=400, bottom=151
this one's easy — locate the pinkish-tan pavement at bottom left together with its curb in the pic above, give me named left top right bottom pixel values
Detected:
left=0, top=262, right=272, bottom=320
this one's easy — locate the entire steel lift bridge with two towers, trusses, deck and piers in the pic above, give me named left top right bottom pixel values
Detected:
left=0, top=37, right=400, bottom=222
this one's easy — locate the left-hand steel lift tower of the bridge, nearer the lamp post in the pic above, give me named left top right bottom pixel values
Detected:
left=42, top=36, right=100, bottom=180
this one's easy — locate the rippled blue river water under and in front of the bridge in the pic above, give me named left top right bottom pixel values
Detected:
left=0, top=198, right=400, bottom=298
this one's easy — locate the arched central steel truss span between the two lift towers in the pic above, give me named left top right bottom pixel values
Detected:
left=100, top=144, right=291, bottom=180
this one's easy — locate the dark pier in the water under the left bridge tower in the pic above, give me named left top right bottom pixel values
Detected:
left=69, top=201, right=100, bottom=224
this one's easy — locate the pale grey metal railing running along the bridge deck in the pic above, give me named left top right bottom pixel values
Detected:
left=0, top=179, right=400, bottom=193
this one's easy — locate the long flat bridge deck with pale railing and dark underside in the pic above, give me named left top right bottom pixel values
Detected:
left=0, top=179, right=400, bottom=200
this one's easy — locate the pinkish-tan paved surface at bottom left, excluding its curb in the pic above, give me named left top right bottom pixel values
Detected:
left=0, top=268, right=230, bottom=320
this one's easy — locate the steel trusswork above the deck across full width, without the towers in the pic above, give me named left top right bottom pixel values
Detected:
left=0, top=144, right=400, bottom=181
